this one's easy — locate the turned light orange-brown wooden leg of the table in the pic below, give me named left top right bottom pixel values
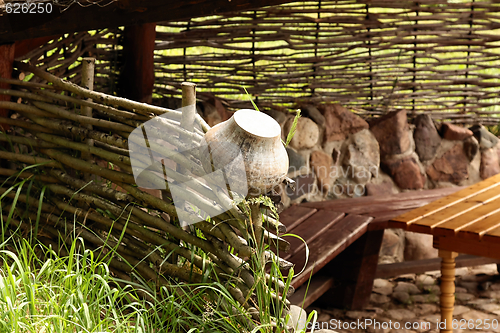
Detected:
left=439, top=250, right=458, bottom=332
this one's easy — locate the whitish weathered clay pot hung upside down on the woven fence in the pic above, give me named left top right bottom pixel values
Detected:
left=200, top=109, right=288, bottom=196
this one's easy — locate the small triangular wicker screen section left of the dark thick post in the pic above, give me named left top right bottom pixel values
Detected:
left=16, top=29, right=119, bottom=93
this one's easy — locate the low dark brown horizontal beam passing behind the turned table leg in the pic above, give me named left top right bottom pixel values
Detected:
left=375, top=254, right=500, bottom=279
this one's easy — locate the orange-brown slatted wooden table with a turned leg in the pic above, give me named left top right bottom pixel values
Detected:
left=389, top=174, right=500, bottom=332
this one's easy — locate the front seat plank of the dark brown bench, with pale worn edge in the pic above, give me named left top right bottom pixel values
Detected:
left=289, top=215, right=372, bottom=288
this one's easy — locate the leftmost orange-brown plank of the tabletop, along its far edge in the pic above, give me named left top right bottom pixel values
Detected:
left=392, top=174, right=500, bottom=224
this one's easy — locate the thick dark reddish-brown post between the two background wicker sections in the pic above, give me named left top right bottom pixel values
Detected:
left=118, top=23, right=156, bottom=103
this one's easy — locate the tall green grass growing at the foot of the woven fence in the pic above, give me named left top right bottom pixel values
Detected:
left=0, top=238, right=264, bottom=333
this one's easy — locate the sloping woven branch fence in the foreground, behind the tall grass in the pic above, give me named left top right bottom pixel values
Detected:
left=0, top=61, right=293, bottom=329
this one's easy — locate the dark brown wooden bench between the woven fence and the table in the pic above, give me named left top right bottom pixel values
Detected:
left=280, top=187, right=494, bottom=309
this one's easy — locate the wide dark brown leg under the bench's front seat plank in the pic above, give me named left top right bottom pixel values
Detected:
left=318, top=230, right=384, bottom=310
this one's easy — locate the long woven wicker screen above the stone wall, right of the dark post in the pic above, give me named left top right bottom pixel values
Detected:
left=155, top=0, right=500, bottom=124
